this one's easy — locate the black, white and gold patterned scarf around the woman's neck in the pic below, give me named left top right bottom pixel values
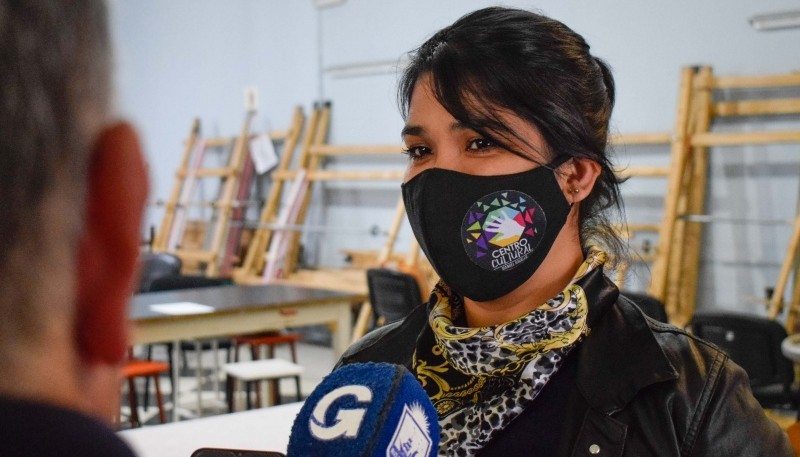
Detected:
left=413, top=250, right=606, bottom=456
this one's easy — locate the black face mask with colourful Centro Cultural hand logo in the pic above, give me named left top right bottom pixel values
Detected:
left=402, top=156, right=570, bottom=301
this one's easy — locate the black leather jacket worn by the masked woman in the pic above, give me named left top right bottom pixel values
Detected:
left=340, top=273, right=794, bottom=457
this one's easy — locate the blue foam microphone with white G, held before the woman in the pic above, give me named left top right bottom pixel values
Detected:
left=287, top=363, right=439, bottom=457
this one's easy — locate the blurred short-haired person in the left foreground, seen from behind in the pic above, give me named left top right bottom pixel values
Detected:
left=0, top=0, right=147, bottom=457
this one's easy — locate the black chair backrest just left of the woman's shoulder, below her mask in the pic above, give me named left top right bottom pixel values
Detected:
left=367, top=268, right=422, bottom=324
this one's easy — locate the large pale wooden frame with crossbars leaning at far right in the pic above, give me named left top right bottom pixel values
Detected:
left=648, top=67, right=800, bottom=325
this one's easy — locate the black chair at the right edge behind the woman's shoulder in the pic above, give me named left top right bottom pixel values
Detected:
left=687, top=311, right=797, bottom=408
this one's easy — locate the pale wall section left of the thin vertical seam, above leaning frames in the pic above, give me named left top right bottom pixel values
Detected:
left=111, top=0, right=319, bottom=228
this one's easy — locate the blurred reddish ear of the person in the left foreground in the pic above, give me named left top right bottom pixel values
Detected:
left=75, top=123, right=148, bottom=364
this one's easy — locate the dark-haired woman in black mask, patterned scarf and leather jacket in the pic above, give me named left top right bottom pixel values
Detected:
left=342, top=8, right=792, bottom=456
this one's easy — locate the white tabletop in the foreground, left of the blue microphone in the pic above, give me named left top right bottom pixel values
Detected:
left=118, top=403, right=303, bottom=457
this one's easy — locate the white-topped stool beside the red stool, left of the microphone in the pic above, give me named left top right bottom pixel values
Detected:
left=222, top=359, right=303, bottom=412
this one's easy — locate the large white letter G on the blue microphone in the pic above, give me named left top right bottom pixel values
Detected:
left=308, top=385, right=372, bottom=441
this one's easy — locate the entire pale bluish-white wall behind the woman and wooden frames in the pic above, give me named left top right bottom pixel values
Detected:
left=113, top=0, right=800, bottom=314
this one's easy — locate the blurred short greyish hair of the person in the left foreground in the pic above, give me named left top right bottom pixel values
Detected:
left=0, top=0, right=110, bottom=348
